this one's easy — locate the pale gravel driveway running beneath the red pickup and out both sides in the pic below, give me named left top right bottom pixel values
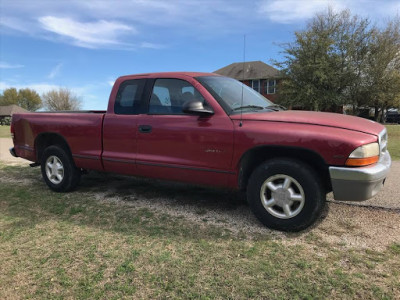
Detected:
left=0, top=138, right=400, bottom=251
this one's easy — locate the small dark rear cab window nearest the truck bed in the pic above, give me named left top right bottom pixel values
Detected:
left=114, top=79, right=146, bottom=115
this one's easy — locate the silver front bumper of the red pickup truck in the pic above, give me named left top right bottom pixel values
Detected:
left=329, top=151, right=392, bottom=201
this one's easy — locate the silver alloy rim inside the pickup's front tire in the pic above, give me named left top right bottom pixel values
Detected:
left=260, top=174, right=305, bottom=219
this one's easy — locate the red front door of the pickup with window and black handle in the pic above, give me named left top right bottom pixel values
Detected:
left=136, top=78, right=233, bottom=185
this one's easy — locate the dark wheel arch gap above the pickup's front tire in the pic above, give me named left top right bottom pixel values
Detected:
left=237, top=145, right=332, bottom=192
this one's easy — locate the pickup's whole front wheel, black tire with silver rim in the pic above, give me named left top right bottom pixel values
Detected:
left=247, top=158, right=326, bottom=231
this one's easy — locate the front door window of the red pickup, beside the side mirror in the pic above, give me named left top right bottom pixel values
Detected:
left=149, top=78, right=206, bottom=115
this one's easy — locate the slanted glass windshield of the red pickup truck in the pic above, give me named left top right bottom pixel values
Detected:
left=196, top=76, right=277, bottom=115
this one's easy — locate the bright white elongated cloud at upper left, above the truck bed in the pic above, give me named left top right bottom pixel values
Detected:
left=39, top=16, right=137, bottom=48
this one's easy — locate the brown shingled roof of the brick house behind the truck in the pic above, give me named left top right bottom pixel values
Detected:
left=214, top=60, right=280, bottom=80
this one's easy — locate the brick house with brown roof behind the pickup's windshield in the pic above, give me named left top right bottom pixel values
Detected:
left=214, top=60, right=281, bottom=102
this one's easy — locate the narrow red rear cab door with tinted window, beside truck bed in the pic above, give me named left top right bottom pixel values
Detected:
left=102, top=79, right=147, bottom=175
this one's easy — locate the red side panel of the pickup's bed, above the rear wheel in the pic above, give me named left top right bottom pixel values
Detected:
left=13, top=111, right=105, bottom=170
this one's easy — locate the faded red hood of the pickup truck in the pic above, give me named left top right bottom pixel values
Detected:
left=230, top=110, right=385, bottom=135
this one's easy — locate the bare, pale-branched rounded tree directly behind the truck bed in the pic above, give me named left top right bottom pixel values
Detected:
left=42, top=88, right=81, bottom=111
